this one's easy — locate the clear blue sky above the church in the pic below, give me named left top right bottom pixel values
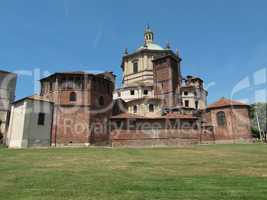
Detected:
left=0, top=0, right=267, bottom=102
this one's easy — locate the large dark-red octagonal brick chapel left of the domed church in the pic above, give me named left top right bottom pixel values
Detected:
left=41, top=73, right=114, bottom=145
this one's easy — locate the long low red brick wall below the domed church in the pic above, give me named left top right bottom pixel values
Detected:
left=110, top=119, right=217, bottom=147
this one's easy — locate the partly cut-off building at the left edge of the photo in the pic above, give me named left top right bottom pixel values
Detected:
left=0, top=70, right=17, bottom=143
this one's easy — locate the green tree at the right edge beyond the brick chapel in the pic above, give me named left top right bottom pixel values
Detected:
left=250, top=103, right=267, bottom=142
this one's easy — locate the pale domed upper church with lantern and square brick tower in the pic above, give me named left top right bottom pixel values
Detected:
left=114, top=26, right=207, bottom=116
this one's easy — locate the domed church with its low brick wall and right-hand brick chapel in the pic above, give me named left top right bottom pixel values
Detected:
left=110, top=26, right=252, bottom=147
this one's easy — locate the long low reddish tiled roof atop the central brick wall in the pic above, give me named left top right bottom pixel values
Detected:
left=111, top=113, right=197, bottom=120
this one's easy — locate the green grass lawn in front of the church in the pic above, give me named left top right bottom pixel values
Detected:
left=0, top=145, right=267, bottom=200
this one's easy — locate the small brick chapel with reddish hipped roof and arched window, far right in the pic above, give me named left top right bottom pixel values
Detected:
left=203, top=98, right=252, bottom=143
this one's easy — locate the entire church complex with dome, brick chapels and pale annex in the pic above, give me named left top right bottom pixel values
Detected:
left=7, top=26, right=252, bottom=148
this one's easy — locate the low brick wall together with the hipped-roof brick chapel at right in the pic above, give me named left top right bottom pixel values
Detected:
left=110, top=99, right=252, bottom=147
